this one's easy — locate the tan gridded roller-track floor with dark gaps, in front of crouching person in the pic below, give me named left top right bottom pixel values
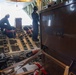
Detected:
left=0, top=30, right=39, bottom=54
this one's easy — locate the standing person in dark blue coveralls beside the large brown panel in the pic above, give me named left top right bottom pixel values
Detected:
left=32, top=6, right=39, bottom=41
